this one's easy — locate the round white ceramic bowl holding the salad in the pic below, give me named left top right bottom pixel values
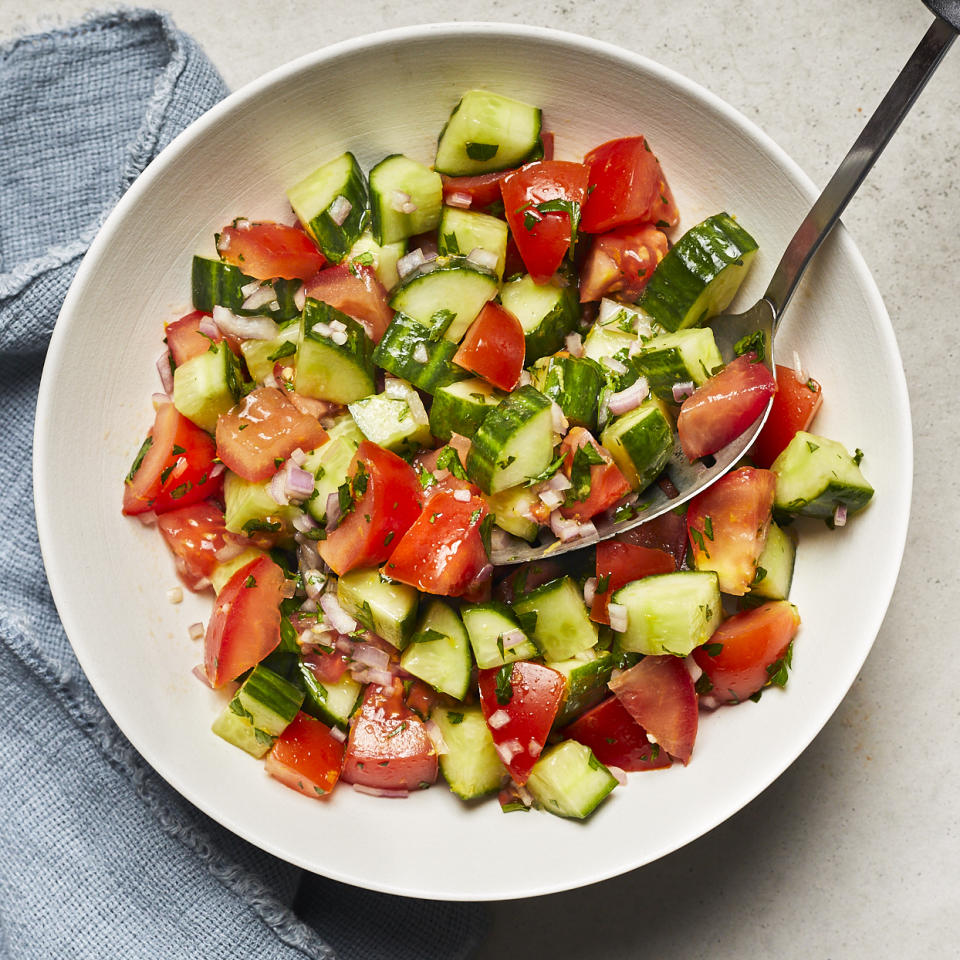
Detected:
left=34, top=24, right=912, bottom=899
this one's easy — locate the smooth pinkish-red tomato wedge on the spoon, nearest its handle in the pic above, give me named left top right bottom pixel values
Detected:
left=677, top=353, right=777, bottom=461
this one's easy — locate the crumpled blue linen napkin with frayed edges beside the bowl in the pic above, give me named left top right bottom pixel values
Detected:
left=0, top=10, right=485, bottom=960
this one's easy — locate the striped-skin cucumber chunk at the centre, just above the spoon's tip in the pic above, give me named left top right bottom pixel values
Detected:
left=466, top=386, right=553, bottom=493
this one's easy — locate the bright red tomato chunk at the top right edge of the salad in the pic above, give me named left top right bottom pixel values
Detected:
left=580, top=137, right=680, bottom=233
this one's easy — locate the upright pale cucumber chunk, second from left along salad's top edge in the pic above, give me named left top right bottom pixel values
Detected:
left=370, top=153, right=443, bottom=244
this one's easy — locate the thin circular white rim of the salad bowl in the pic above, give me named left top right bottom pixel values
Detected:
left=33, top=21, right=913, bottom=900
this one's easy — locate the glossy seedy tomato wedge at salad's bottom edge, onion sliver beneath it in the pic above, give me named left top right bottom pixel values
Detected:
left=341, top=681, right=437, bottom=790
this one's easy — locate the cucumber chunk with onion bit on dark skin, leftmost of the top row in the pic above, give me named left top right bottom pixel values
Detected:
left=287, top=152, right=367, bottom=263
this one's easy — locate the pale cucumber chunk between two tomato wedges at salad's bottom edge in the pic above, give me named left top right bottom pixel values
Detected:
left=430, top=706, right=507, bottom=800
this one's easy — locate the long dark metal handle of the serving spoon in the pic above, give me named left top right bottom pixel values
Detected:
left=764, top=17, right=957, bottom=323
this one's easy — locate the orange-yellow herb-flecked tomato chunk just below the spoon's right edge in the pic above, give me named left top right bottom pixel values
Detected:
left=687, top=467, right=777, bottom=597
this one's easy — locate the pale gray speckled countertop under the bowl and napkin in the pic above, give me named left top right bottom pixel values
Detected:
left=0, top=0, right=960, bottom=960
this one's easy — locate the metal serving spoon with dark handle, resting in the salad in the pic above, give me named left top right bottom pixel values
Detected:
left=490, top=0, right=960, bottom=564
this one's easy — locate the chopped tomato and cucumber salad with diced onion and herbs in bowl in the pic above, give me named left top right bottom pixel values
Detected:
left=123, top=90, right=873, bottom=818
